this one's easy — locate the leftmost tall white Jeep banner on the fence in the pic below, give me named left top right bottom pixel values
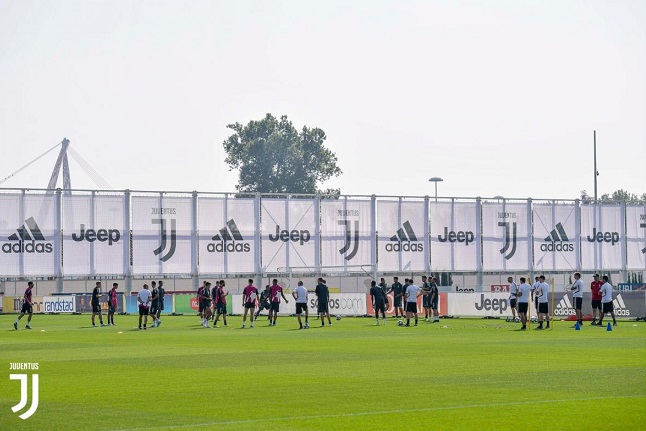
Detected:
left=63, top=195, right=127, bottom=275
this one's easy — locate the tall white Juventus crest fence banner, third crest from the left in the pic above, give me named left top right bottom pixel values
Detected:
left=482, top=202, right=531, bottom=271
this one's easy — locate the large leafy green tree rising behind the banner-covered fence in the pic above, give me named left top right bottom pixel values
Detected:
left=223, top=114, right=342, bottom=194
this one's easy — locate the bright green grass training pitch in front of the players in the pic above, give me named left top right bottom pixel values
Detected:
left=0, top=315, right=646, bottom=431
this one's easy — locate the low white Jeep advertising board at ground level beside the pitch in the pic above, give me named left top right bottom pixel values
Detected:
left=446, top=292, right=511, bottom=317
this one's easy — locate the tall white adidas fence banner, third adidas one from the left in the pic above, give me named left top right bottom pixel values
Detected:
left=377, top=201, right=428, bottom=272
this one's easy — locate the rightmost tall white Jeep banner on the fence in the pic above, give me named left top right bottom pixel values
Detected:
left=581, top=205, right=624, bottom=270
